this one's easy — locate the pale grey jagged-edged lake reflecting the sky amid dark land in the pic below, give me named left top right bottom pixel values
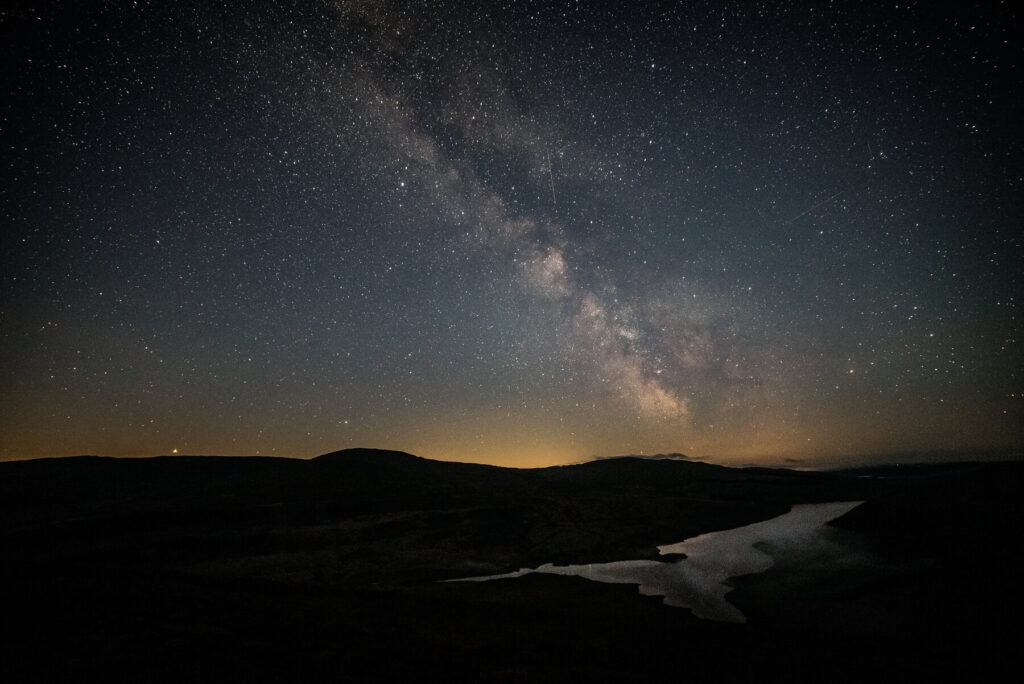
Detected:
left=452, top=502, right=860, bottom=623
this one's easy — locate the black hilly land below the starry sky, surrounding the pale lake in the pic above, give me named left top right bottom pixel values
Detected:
left=0, top=450, right=1024, bottom=681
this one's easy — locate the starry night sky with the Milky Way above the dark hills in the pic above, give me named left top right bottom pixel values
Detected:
left=0, top=0, right=1024, bottom=466
